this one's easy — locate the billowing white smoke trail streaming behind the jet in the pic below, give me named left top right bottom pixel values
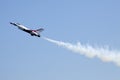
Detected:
left=44, top=37, right=120, bottom=66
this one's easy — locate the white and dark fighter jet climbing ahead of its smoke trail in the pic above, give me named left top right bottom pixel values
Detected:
left=10, top=22, right=44, bottom=37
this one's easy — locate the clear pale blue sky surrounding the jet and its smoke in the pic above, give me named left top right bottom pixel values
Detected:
left=0, top=0, right=120, bottom=80
